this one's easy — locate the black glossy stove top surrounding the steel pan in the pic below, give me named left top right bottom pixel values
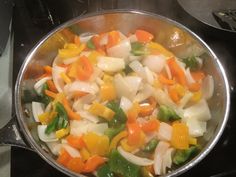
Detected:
left=11, top=0, right=236, bottom=177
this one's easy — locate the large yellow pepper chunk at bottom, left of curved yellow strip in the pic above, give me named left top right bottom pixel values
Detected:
left=83, top=132, right=109, bottom=156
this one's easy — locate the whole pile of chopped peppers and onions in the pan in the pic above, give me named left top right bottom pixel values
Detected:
left=29, top=30, right=214, bottom=177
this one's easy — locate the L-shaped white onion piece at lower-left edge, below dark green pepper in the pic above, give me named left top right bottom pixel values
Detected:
left=38, top=125, right=58, bottom=142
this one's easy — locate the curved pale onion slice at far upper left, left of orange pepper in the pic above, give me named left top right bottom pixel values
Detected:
left=52, top=66, right=66, bottom=92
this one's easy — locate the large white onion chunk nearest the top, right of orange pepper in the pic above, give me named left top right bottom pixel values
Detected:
left=107, top=39, right=131, bottom=58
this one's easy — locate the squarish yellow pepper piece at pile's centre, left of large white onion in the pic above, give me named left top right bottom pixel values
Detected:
left=100, top=83, right=116, bottom=101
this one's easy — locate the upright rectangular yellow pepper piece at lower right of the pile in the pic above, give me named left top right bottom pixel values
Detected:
left=171, top=123, right=189, bottom=149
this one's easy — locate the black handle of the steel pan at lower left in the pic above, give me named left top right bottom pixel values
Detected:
left=0, top=117, right=33, bottom=151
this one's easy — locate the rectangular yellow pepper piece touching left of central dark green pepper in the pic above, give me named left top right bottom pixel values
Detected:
left=88, top=102, right=115, bottom=121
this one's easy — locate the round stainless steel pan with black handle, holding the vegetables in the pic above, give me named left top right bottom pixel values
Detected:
left=0, top=10, right=230, bottom=176
